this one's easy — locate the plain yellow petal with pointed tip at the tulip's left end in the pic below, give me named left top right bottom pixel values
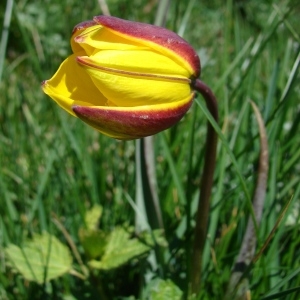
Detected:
left=42, top=53, right=107, bottom=115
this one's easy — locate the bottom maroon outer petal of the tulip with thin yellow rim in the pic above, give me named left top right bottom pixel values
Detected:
left=72, top=94, right=194, bottom=140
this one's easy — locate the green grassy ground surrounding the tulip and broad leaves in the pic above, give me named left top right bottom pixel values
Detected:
left=0, top=0, right=300, bottom=300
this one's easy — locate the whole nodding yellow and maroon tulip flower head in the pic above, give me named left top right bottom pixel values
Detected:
left=42, top=16, right=200, bottom=140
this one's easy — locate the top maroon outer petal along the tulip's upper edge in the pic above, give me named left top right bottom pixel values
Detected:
left=94, top=16, right=200, bottom=77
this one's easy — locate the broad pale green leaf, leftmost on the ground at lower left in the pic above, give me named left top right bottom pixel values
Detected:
left=5, top=232, right=72, bottom=284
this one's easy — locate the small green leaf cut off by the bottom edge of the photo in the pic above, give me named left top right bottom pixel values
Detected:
left=150, top=279, right=182, bottom=300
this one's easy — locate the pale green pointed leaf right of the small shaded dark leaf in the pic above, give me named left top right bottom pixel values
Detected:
left=89, top=228, right=150, bottom=270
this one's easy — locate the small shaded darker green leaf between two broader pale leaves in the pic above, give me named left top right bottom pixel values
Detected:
left=79, top=228, right=107, bottom=259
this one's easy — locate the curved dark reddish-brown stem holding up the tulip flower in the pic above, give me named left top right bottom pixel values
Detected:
left=190, top=79, right=218, bottom=294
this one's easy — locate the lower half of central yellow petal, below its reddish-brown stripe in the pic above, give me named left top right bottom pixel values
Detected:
left=77, top=57, right=191, bottom=107
